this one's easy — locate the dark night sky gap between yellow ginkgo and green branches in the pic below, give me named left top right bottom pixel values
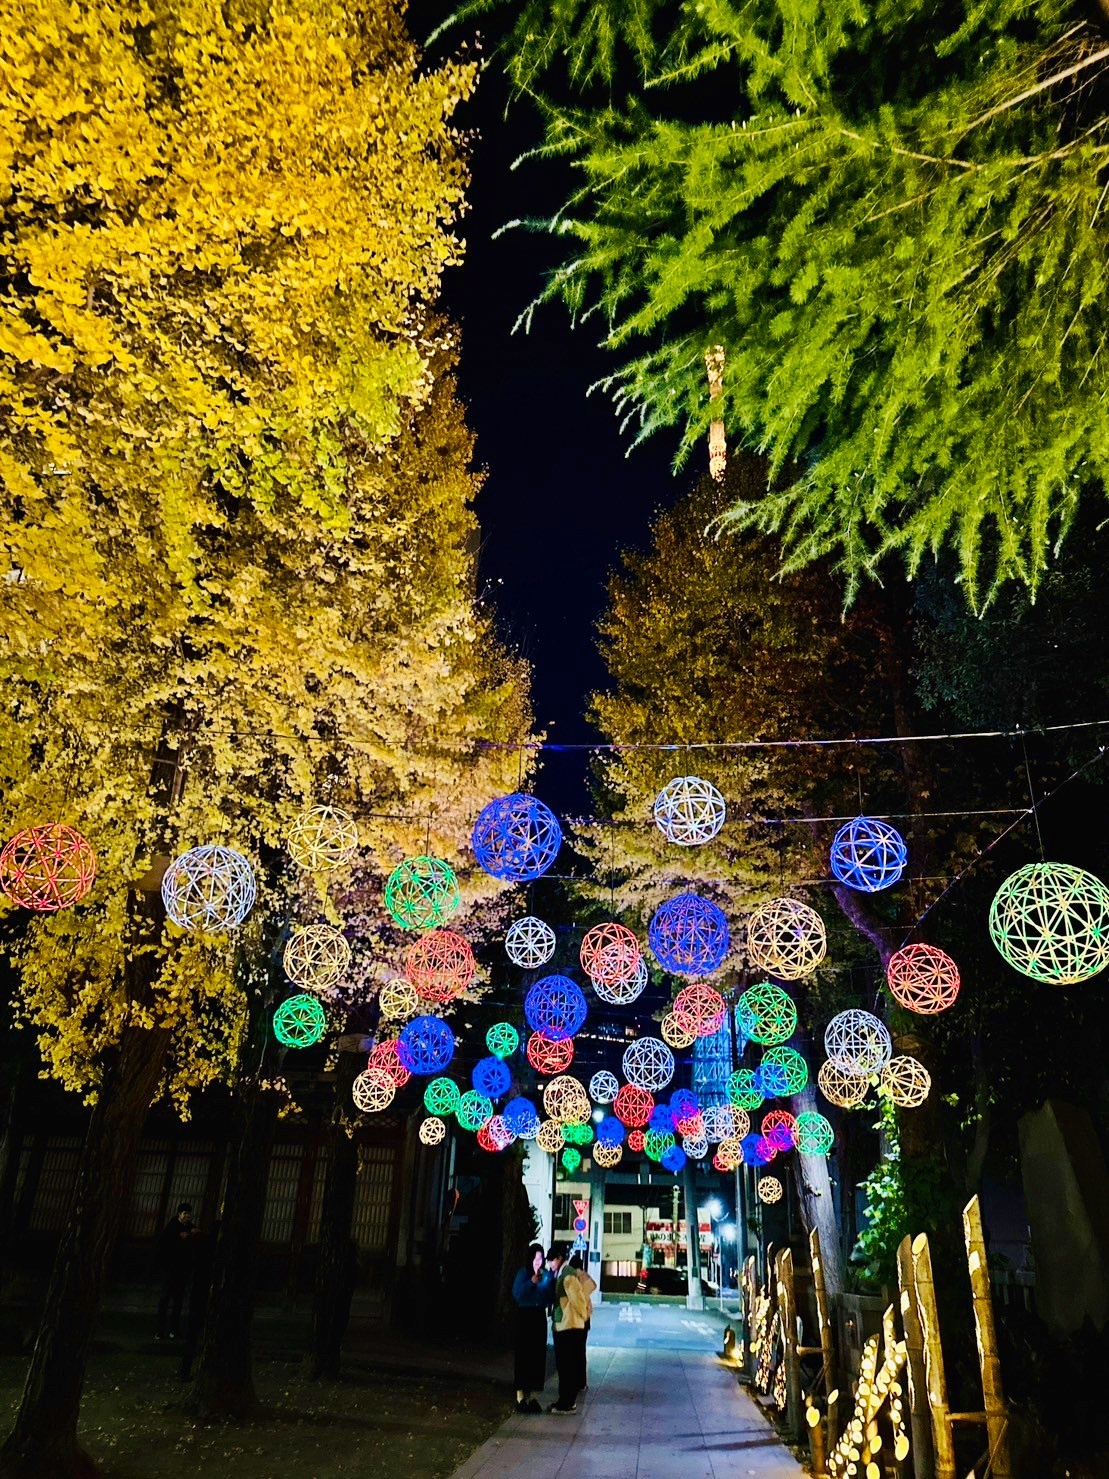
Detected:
left=410, top=0, right=683, bottom=813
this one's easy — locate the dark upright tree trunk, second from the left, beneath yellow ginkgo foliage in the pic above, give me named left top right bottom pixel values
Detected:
left=194, top=1084, right=278, bottom=1418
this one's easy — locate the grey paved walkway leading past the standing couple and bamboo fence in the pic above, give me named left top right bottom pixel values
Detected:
left=454, top=1302, right=803, bottom=1479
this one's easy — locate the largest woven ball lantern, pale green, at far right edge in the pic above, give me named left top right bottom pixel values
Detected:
left=989, top=862, right=1109, bottom=986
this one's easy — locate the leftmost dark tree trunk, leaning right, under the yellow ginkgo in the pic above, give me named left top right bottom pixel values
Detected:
left=0, top=1026, right=169, bottom=1479
